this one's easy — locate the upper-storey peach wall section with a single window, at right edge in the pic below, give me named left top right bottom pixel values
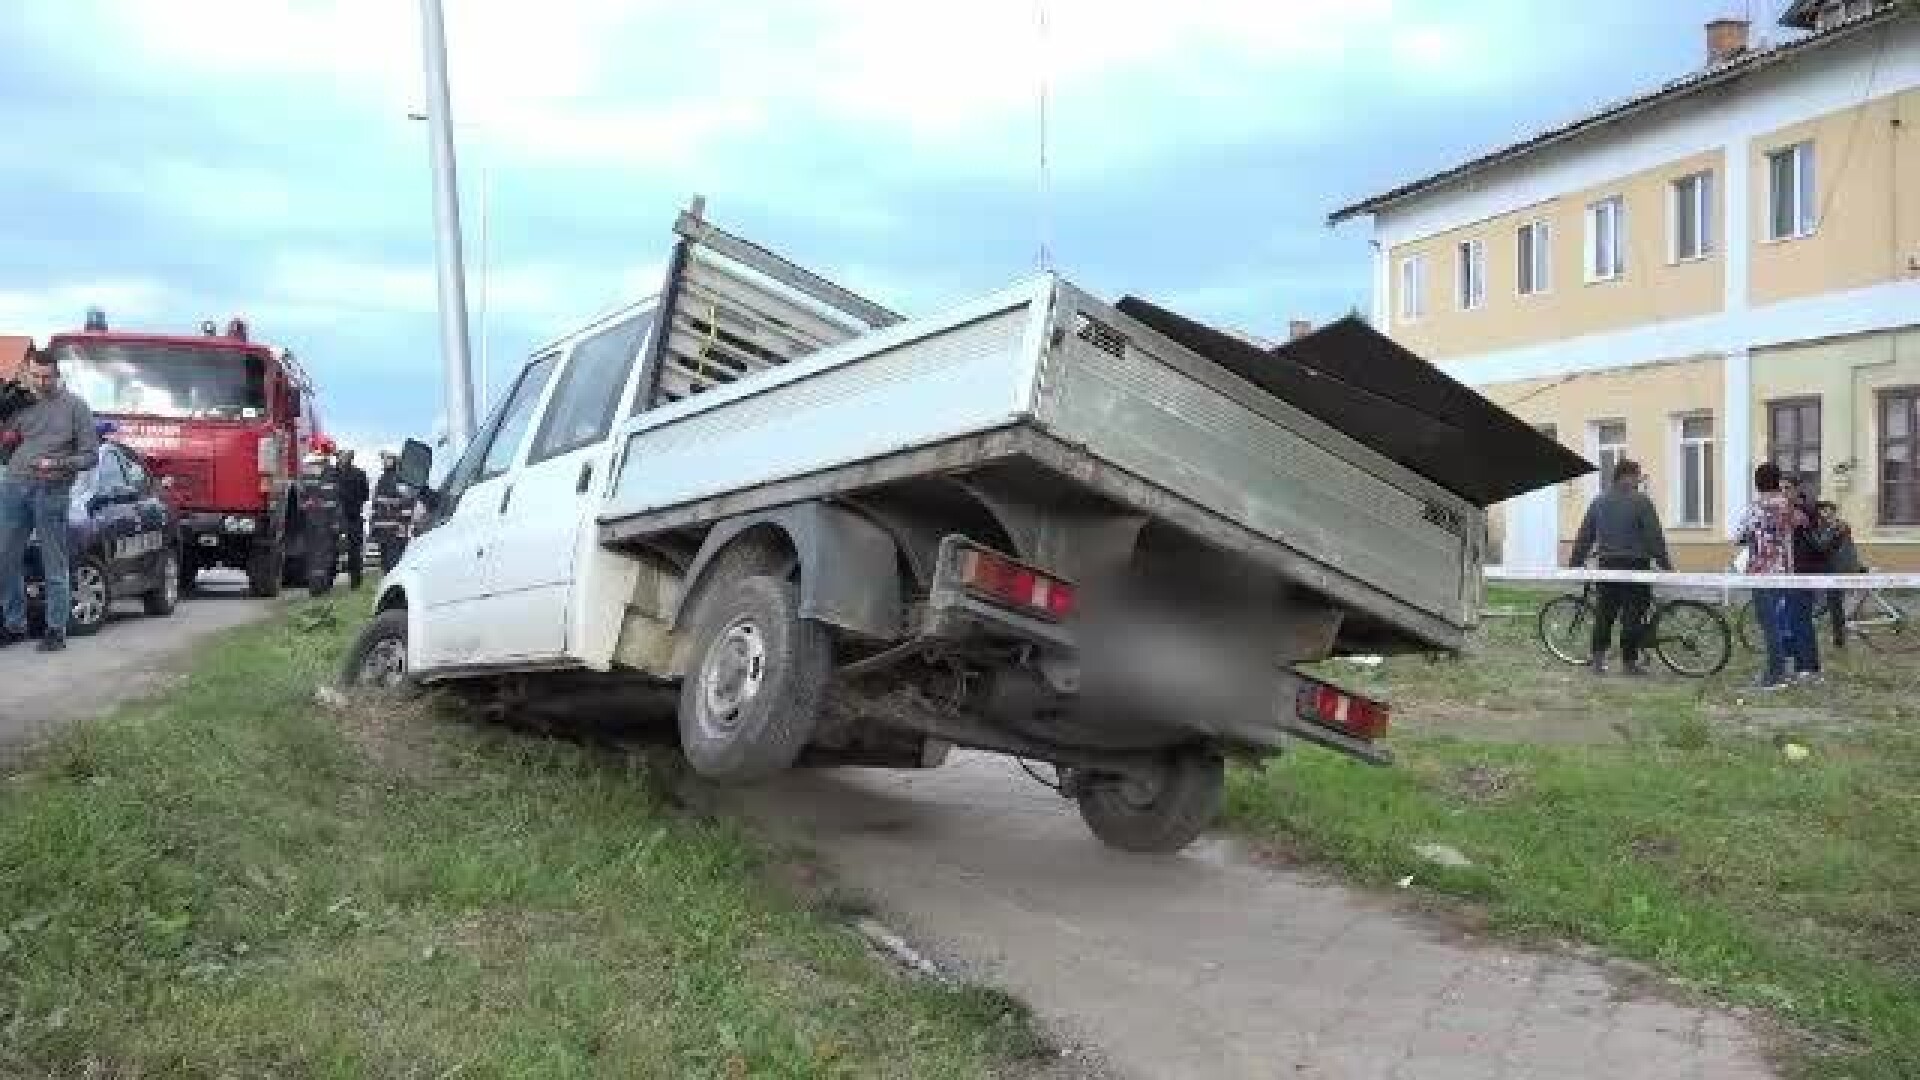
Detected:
left=1749, top=90, right=1920, bottom=306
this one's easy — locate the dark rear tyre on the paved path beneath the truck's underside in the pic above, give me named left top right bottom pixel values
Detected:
left=1075, top=749, right=1227, bottom=853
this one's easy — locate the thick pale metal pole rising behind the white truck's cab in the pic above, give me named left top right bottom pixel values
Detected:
left=420, top=0, right=474, bottom=454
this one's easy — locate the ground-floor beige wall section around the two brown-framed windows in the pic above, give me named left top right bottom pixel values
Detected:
left=1753, top=331, right=1920, bottom=571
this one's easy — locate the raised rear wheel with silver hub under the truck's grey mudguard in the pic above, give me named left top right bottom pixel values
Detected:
left=680, top=575, right=833, bottom=782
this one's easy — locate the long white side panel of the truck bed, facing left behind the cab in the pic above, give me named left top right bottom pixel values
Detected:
left=601, top=302, right=1033, bottom=523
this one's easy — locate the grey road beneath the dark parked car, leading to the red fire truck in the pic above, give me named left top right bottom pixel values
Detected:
left=0, top=573, right=276, bottom=748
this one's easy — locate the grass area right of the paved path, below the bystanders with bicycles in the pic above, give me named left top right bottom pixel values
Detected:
left=1229, top=594, right=1920, bottom=1080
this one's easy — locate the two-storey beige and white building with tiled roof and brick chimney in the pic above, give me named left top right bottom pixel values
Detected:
left=1332, top=0, right=1920, bottom=571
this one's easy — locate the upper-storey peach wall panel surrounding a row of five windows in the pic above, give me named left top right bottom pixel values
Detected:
left=1388, top=150, right=1735, bottom=359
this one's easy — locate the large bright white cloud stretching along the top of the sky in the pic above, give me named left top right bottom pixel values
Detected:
left=48, top=0, right=1528, bottom=186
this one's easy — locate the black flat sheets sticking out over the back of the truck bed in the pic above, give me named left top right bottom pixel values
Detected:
left=1117, top=296, right=1594, bottom=507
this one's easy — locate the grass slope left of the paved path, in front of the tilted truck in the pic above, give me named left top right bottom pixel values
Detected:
left=0, top=605, right=1041, bottom=1080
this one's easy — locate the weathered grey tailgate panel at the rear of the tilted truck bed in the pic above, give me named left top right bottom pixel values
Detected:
left=1039, top=297, right=1473, bottom=625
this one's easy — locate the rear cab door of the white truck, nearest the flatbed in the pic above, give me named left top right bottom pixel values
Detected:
left=482, top=303, right=653, bottom=661
